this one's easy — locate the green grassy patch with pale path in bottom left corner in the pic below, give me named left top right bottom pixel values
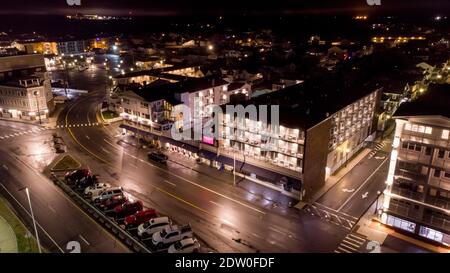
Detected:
left=0, top=197, right=39, bottom=253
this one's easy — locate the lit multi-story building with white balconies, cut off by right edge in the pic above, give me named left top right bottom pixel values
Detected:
left=381, top=84, right=450, bottom=246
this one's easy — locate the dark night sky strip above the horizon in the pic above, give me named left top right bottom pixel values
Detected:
left=0, top=0, right=450, bottom=15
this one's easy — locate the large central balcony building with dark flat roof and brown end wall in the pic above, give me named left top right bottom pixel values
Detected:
left=217, top=81, right=380, bottom=198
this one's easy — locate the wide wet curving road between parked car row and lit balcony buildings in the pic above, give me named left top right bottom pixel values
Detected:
left=54, top=71, right=347, bottom=252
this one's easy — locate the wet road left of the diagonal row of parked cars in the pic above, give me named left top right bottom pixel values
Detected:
left=0, top=121, right=129, bottom=253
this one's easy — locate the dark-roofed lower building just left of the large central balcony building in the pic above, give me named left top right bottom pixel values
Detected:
left=109, top=77, right=232, bottom=131
